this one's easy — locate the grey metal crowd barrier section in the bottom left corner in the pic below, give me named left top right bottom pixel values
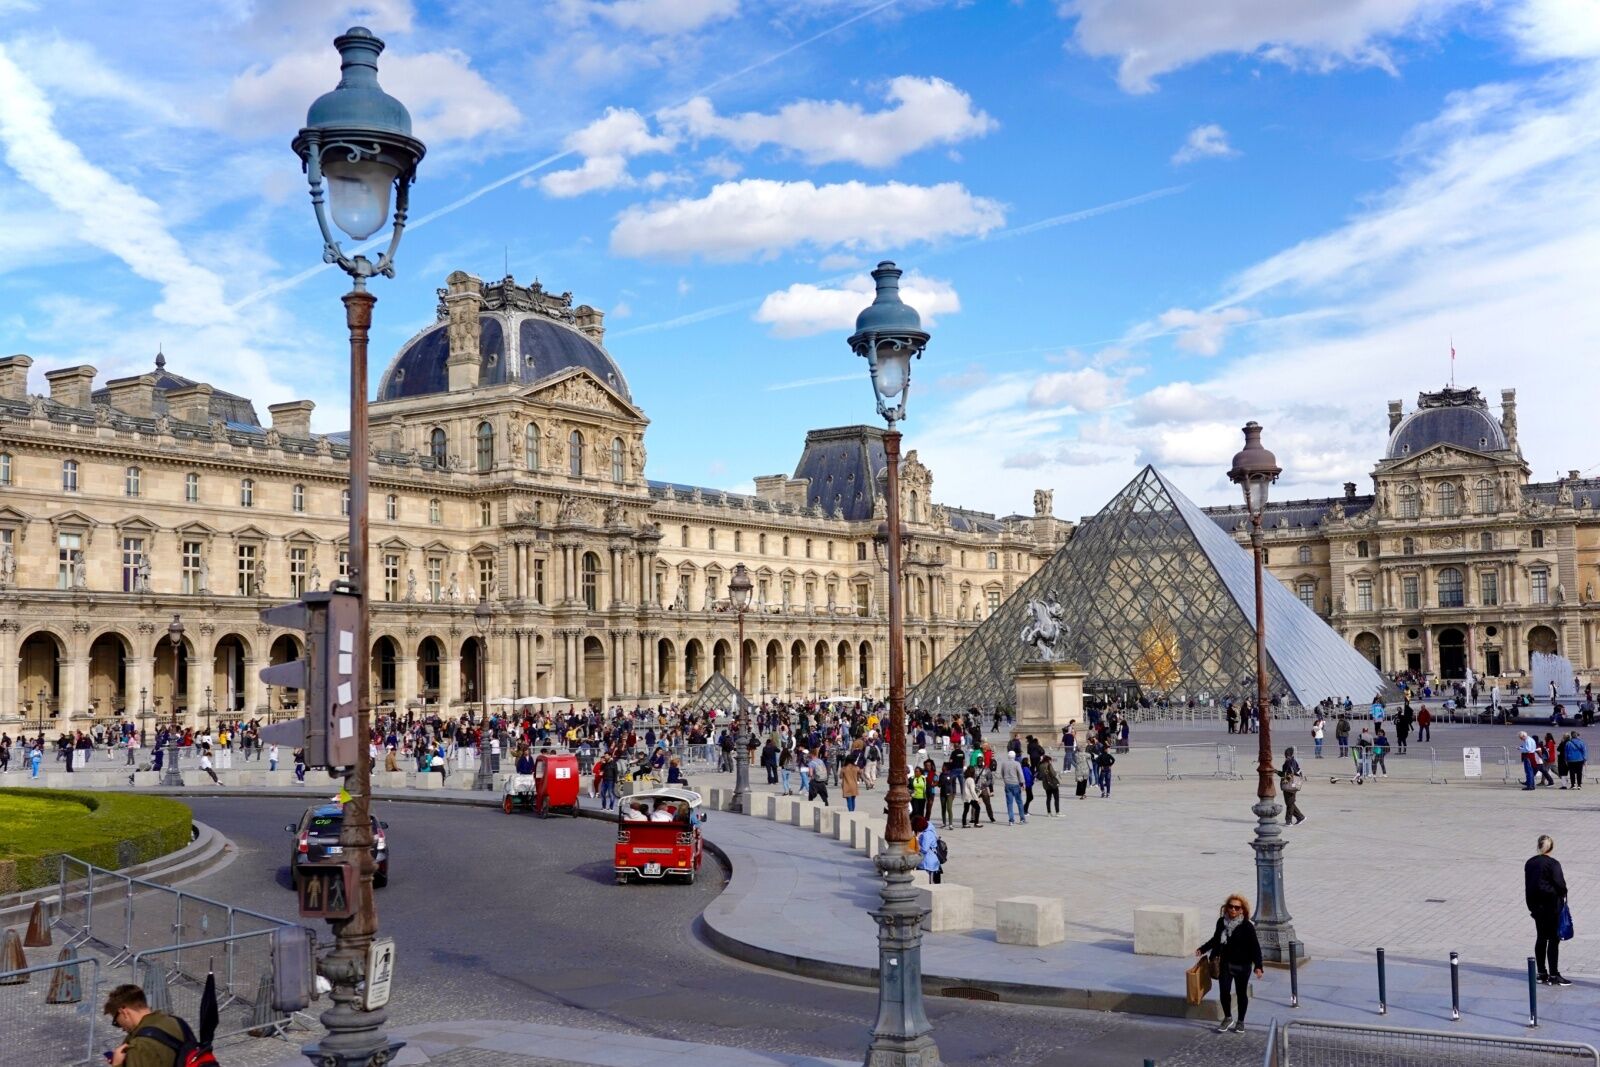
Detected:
left=0, top=957, right=106, bottom=1064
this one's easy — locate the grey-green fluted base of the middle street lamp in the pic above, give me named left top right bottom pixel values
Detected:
left=862, top=843, right=942, bottom=1067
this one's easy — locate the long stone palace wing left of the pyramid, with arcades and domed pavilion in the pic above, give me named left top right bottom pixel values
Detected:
left=0, top=272, right=1075, bottom=729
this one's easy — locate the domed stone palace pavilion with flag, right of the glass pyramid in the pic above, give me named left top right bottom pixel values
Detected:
left=1206, top=387, right=1600, bottom=685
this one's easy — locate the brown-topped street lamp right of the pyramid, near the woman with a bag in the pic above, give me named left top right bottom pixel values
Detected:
left=1227, top=421, right=1306, bottom=963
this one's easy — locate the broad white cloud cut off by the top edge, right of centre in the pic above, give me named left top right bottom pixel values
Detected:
left=1059, top=0, right=1472, bottom=93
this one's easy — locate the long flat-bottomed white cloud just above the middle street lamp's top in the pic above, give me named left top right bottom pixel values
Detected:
left=611, top=178, right=1005, bottom=261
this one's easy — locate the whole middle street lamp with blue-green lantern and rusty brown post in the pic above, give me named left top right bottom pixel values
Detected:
left=850, top=262, right=939, bottom=1067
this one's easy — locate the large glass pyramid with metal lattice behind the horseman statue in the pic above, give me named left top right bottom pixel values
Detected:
left=910, top=467, right=1386, bottom=712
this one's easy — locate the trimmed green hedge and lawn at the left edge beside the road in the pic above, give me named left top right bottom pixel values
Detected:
left=0, top=789, right=194, bottom=894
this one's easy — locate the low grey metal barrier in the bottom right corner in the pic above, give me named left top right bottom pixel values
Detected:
left=1264, top=1019, right=1600, bottom=1067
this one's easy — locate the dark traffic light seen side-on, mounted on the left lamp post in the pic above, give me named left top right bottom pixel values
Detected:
left=261, top=590, right=366, bottom=768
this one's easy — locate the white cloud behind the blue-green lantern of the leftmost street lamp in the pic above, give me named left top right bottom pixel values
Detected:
left=218, top=43, right=522, bottom=147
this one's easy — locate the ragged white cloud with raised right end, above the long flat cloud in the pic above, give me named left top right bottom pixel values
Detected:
left=658, top=77, right=997, bottom=166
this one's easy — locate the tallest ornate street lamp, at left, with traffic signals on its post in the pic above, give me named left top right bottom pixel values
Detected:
left=293, top=26, right=426, bottom=1067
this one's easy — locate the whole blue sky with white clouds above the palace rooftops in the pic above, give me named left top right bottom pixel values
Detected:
left=0, top=0, right=1600, bottom=517
